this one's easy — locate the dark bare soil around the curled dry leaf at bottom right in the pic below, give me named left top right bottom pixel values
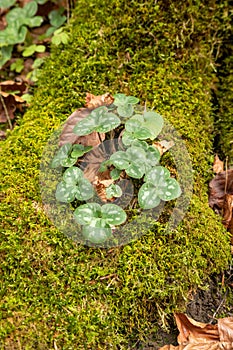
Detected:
left=130, top=265, right=233, bottom=350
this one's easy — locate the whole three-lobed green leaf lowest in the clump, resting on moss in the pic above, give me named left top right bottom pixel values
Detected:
left=74, top=203, right=127, bottom=243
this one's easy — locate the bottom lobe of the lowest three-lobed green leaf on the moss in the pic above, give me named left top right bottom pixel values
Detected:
left=82, top=219, right=112, bottom=244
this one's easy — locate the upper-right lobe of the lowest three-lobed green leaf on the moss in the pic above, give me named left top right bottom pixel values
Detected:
left=101, top=204, right=127, bottom=225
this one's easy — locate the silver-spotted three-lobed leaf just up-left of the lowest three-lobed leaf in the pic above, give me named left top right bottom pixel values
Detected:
left=55, top=167, right=94, bottom=203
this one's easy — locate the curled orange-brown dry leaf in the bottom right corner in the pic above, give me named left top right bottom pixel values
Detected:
left=160, top=313, right=233, bottom=350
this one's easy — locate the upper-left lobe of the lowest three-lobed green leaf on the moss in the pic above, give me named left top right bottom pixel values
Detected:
left=74, top=203, right=101, bottom=225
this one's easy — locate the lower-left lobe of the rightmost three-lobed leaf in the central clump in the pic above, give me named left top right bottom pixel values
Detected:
left=138, top=183, right=160, bottom=209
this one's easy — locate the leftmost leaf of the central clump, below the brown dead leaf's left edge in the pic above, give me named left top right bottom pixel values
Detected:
left=51, top=143, right=92, bottom=168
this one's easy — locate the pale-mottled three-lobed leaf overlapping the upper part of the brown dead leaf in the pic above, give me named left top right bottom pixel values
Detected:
left=73, top=106, right=121, bottom=136
